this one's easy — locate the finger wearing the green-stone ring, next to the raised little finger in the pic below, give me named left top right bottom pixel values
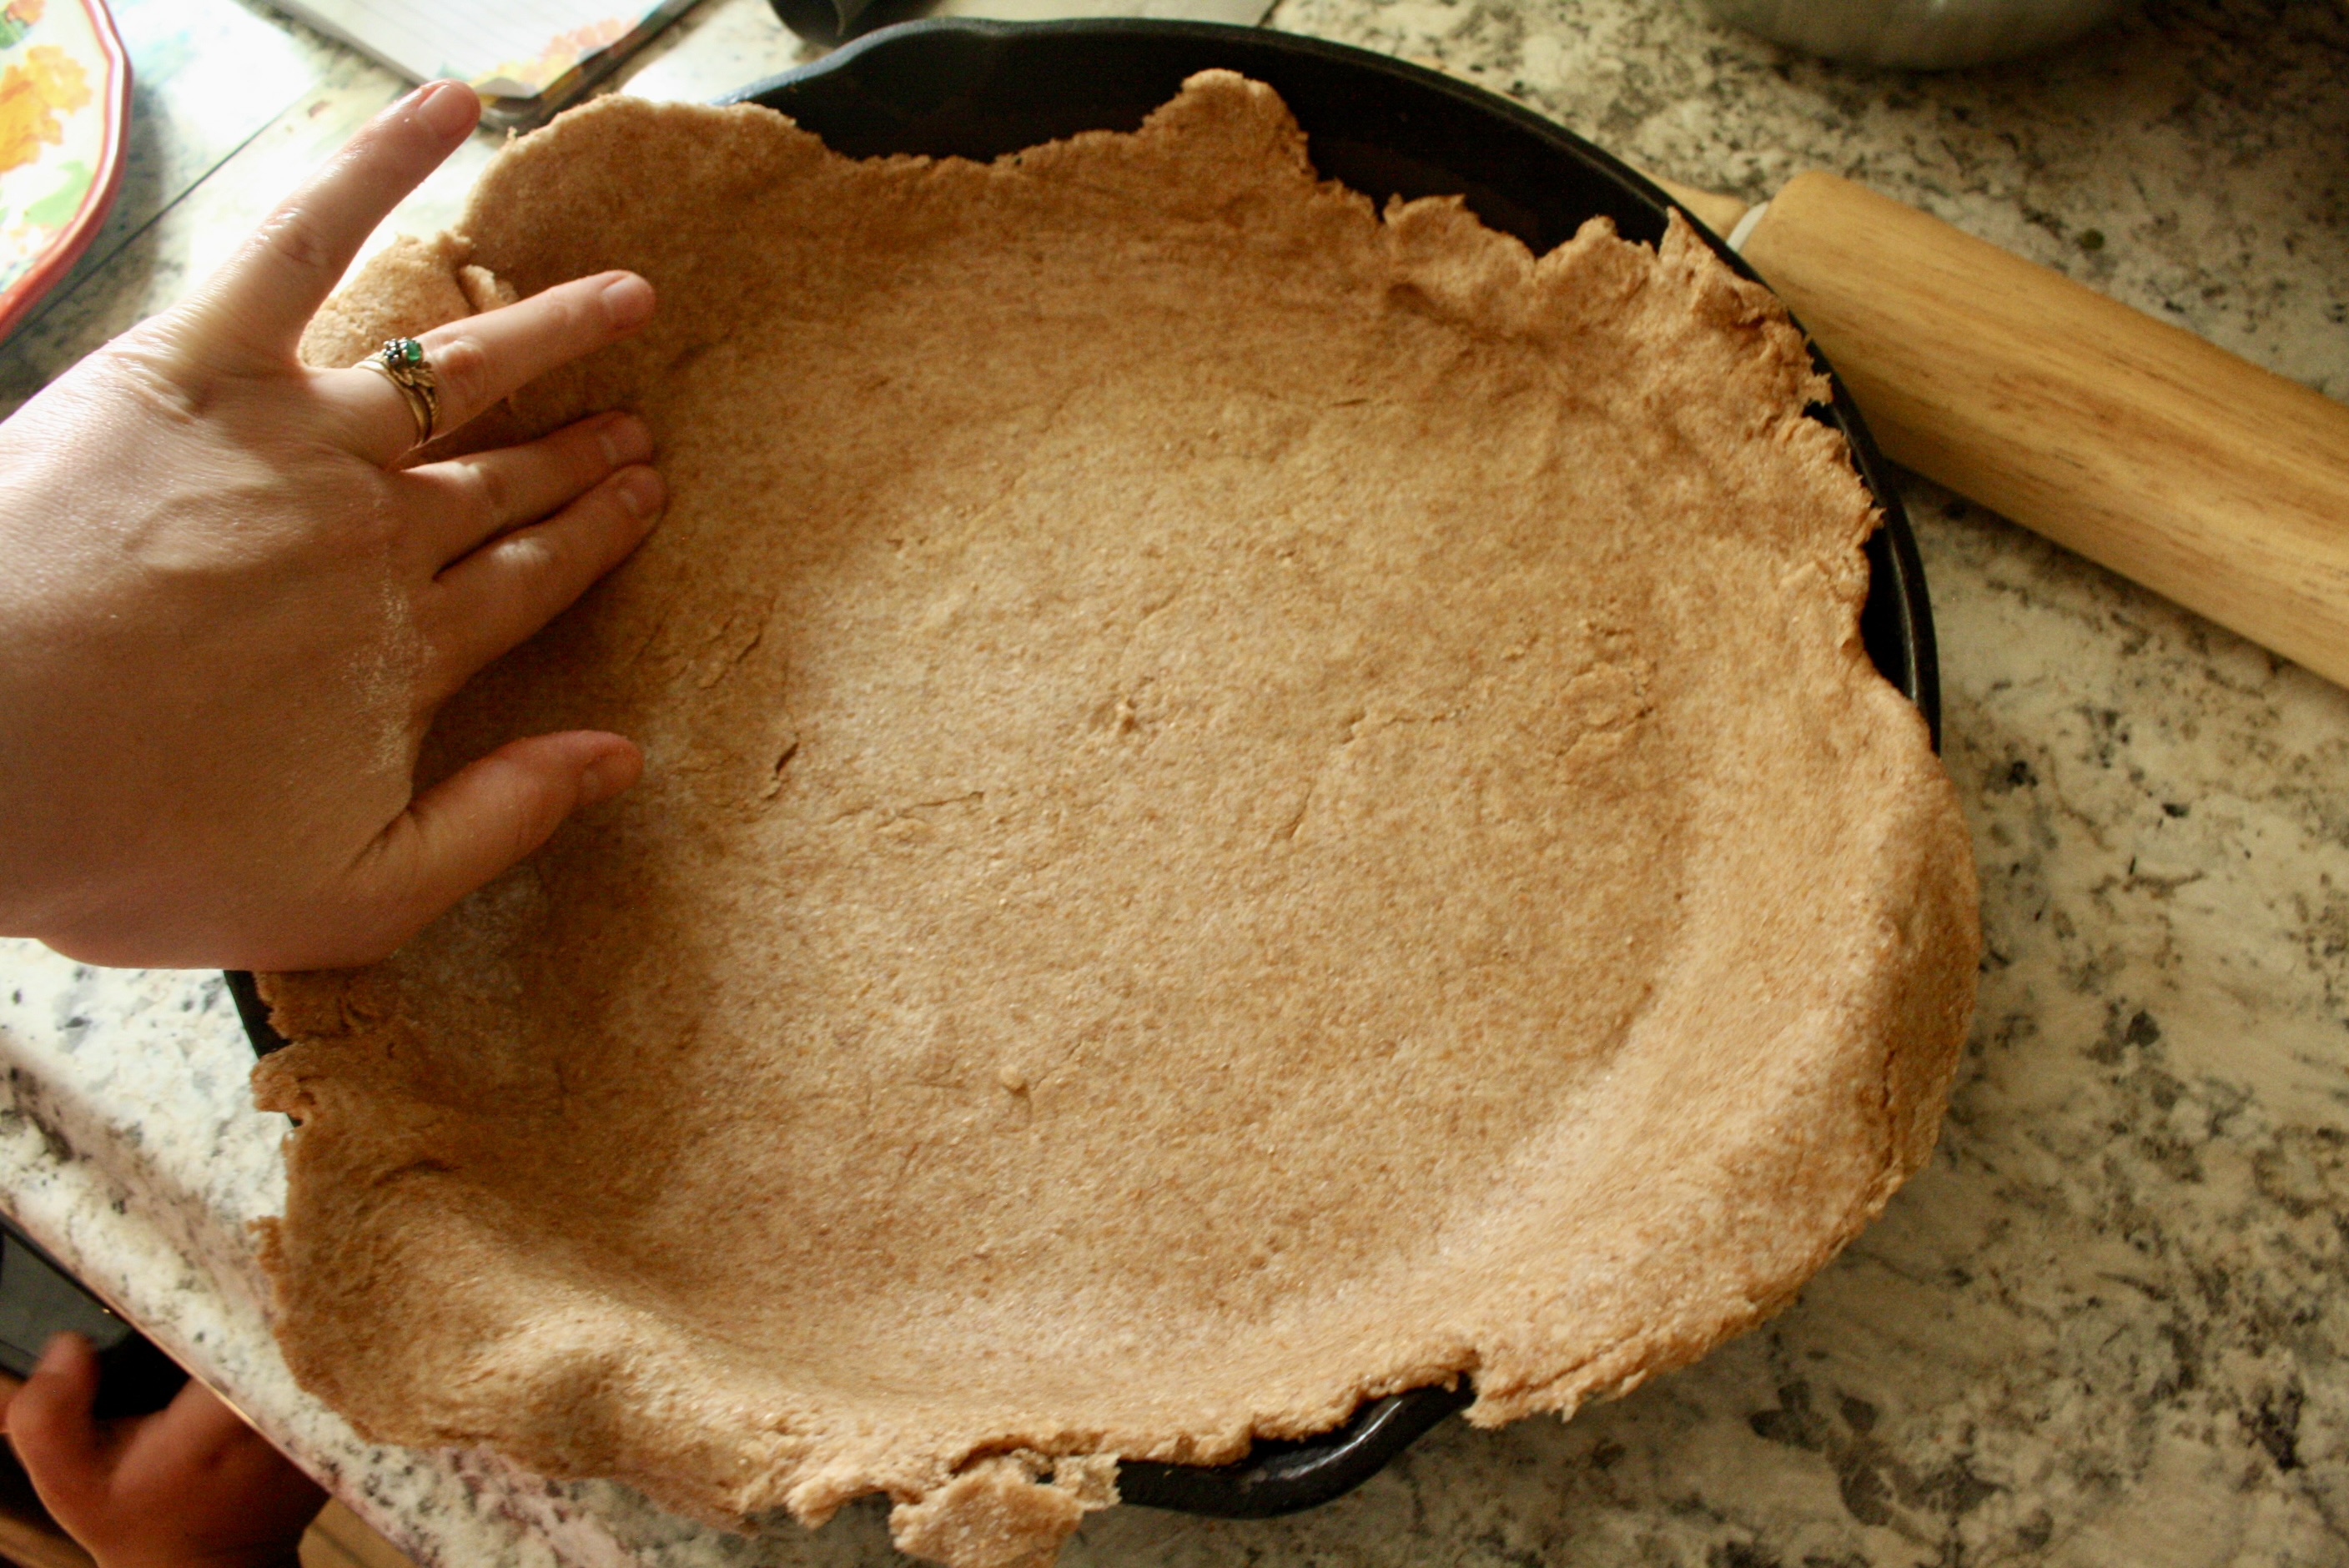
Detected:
left=313, top=272, right=653, bottom=467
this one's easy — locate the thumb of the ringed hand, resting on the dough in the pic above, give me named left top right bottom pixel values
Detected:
left=334, top=730, right=644, bottom=965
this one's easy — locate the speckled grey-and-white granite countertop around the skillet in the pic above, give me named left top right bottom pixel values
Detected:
left=0, top=0, right=2349, bottom=1568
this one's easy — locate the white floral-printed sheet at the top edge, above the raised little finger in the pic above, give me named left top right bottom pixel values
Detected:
left=277, top=0, right=696, bottom=124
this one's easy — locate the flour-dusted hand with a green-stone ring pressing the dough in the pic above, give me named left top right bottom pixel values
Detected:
left=0, top=83, right=662, bottom=969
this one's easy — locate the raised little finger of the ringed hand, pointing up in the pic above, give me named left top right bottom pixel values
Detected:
left=181, top=83, right=481, bottom=371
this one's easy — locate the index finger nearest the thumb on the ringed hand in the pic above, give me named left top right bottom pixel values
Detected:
left=425, top=467, right=667, bottom=692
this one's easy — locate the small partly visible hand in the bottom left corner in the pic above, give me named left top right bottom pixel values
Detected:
left=7, top=1334, right=326, bottom=1568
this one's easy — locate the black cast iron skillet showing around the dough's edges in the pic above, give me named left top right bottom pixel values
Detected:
left=228, top=19, right=1940, bottom=1519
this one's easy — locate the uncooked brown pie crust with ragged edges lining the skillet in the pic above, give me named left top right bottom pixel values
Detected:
left=256, top=73, right=1978, bottom=1568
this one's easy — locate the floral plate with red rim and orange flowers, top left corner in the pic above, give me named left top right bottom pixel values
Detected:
left=0, top=0, right=132, bottom=335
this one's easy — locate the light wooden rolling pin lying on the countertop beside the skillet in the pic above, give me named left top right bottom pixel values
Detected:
left=1738, top=173, right=2349, bottom=686
